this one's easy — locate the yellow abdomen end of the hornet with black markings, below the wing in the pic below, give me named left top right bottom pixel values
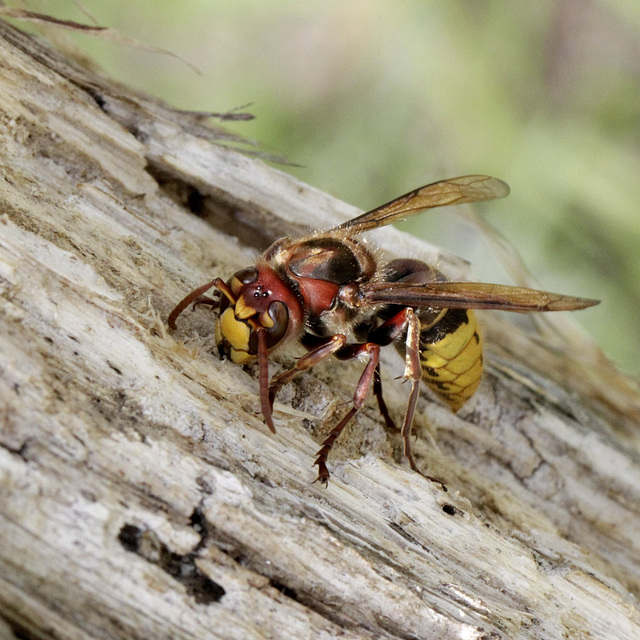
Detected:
left=420, top=309, right=482, bottom=412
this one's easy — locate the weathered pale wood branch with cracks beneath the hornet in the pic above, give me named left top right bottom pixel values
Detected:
left=0, top=22, right=640, bottom=640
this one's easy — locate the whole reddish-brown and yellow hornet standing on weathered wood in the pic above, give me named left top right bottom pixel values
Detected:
left=168, top=175, right=598, bottom=484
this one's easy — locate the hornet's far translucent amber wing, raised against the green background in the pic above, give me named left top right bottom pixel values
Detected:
left=332, top=176, right=509, bottom=235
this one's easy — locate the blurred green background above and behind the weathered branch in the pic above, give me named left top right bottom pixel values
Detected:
left=20, top=0, right=640, bottom=375
